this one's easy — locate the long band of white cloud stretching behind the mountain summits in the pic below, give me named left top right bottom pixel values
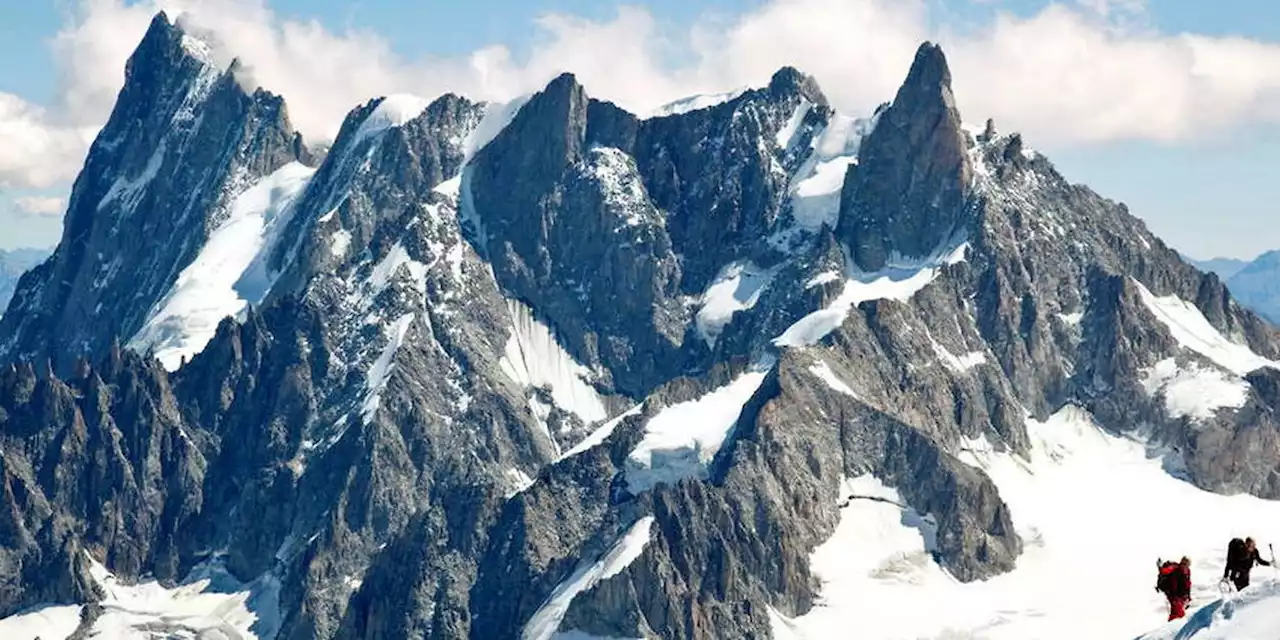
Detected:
left=0, top=0, right=1280, bottom=192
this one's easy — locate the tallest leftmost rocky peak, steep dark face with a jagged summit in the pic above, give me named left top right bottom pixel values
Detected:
left=0, top=7, right=310, bottom=374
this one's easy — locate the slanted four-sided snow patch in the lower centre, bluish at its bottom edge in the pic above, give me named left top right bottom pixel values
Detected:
left=625, top=367, right=768, bottom=493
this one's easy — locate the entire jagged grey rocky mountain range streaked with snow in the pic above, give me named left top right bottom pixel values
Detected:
left=0, top=13, right=1280, bottom=640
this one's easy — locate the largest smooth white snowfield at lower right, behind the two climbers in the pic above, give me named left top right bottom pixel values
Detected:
left=780, top=407, right=1280, bottom=640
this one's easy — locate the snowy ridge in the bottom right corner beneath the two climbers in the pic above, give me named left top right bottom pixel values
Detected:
left=1138, top=579, right=1280, bottom=640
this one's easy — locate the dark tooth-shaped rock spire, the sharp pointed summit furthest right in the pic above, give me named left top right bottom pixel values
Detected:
left=838, top=42, right=973, bottom=270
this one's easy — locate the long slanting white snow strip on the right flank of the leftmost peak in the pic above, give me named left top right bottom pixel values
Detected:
left=129, top=163, right=315, bottom=371
